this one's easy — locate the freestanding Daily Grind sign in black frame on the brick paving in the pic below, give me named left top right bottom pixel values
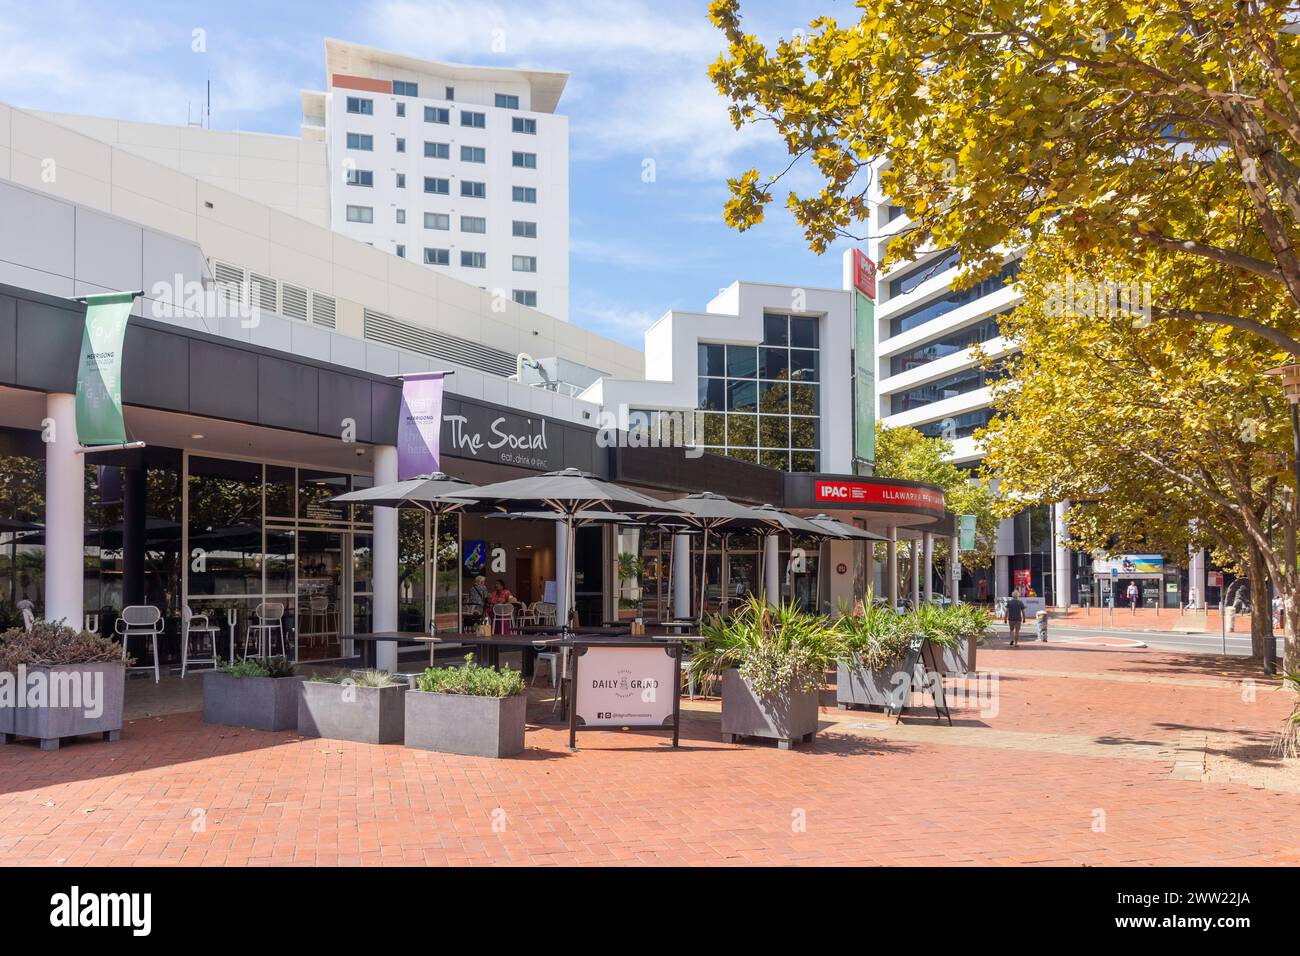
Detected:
left=569, top=639, right=681, bottom=748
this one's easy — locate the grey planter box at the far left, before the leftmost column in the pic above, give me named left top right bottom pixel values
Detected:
left=0, top=661, right=126, bottom=750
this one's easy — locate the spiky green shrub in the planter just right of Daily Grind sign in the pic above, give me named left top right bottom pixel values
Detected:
left=689, top=594, right=842, bottom=696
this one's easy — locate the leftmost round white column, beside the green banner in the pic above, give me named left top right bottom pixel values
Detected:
left=43, top=393, right=86, bottom=630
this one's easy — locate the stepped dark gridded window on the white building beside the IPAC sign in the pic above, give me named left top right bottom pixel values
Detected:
left=697, top=312, right=822, bottom=471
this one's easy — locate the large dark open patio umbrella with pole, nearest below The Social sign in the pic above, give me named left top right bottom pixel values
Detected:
left=434, top=468, right=677, bottom=626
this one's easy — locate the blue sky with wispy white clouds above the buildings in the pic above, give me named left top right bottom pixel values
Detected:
left=0, top=0, right=855, bottom=347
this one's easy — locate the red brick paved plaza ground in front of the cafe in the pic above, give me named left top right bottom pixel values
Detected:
left=0, top=641, right=1300, bottom=866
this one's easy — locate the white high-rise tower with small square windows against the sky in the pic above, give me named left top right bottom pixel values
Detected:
left=302, top=39, right=569, bottom=320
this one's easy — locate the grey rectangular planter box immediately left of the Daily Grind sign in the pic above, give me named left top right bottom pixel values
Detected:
left=406, top=691, right=528, bottom=757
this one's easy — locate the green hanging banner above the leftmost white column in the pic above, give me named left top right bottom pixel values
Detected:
left=77, top=293, right=137, bottom=446
